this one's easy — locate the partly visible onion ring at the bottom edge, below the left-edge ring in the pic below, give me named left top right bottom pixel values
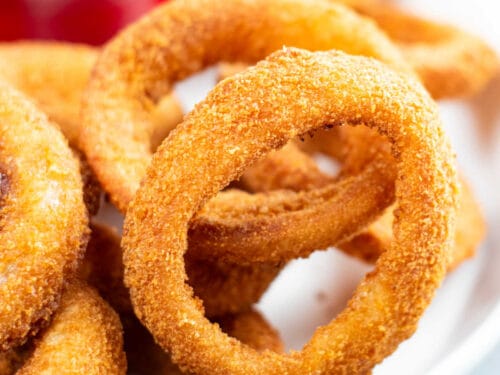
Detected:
left=16, top=281, right=127, bottom=375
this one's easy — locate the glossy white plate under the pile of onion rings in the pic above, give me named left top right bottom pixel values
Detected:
left=98, top=0, right=500, bottom=375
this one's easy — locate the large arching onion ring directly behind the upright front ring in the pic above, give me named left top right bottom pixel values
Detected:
left=80, top=0, right=412, bottom=212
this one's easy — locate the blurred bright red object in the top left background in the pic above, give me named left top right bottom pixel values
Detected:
left=0, top=0, right=163, bottom=45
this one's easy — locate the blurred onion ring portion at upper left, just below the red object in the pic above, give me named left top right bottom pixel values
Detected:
left=0, top=41, right=97, bottom=145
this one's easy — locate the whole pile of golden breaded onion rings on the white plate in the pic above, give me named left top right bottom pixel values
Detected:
left=0, top=0, right=498, bottom=375
